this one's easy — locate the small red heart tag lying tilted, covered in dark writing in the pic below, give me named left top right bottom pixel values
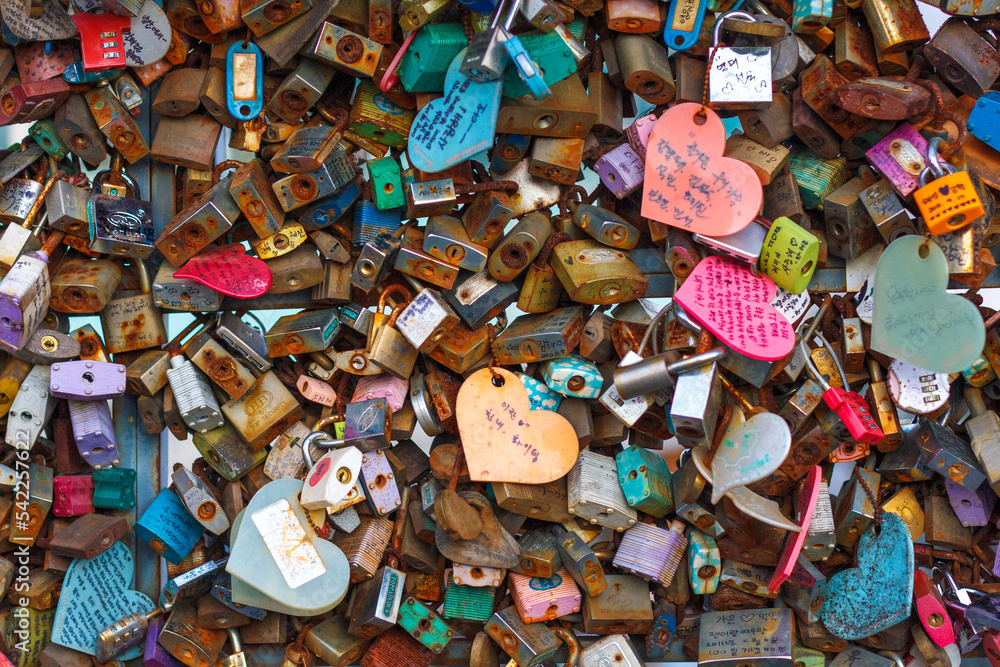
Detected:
left=174, top=243, right=271, bottom=299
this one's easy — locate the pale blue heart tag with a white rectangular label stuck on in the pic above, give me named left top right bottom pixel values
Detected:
left=226, top=479, right=351, bottom=616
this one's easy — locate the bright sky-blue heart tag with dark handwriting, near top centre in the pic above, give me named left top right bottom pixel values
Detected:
left=406, top=49, right=503, bottom=172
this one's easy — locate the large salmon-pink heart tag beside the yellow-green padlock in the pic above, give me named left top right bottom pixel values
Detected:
left=642, top=103, right=764, bottom=236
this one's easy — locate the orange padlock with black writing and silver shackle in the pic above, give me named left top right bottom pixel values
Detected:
left=913, top=137, right=984, bottom=236
